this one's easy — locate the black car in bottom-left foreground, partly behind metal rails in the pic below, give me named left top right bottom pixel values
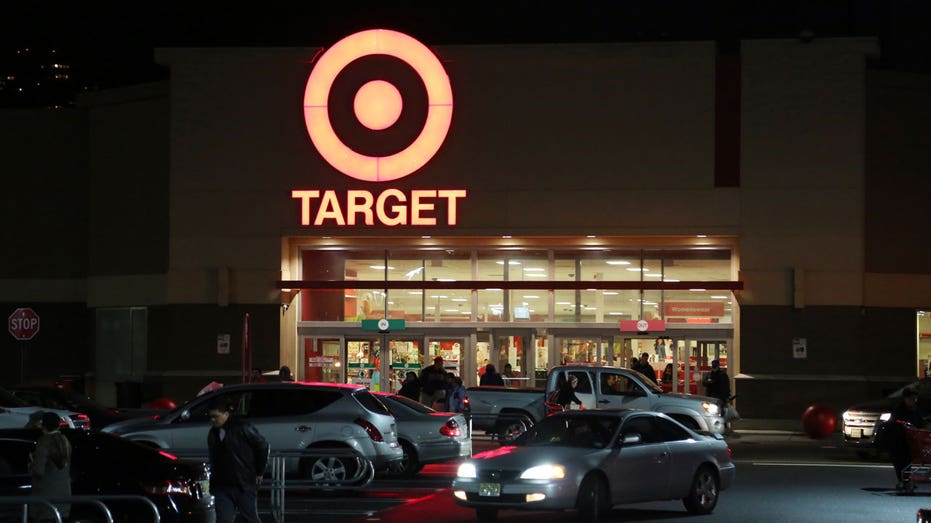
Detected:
left=0, top=429, right=216, bottom=523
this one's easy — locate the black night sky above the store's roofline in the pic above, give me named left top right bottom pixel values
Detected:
left=0, top=0, right=931, bottom=96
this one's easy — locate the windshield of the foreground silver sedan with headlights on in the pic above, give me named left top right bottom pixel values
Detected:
left=514, top=415, right=620, bottom=449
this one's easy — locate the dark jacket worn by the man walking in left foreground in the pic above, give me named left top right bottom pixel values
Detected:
left=207, top=416, right=268, bottom=488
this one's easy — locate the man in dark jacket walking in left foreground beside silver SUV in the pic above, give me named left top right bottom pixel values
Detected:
left=207, top=400, right=268, bottom=523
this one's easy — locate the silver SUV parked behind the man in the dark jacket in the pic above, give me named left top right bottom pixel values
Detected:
left=101, top=382, right=404, bottom=479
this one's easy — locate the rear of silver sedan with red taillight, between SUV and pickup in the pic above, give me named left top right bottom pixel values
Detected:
left=373, top=392, right=472, bottom=477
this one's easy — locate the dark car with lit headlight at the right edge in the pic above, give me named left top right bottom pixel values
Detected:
left=843, top=378, right=931, bottom=457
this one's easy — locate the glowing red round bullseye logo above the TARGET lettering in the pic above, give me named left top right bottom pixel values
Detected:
left=304, top=29, right=453, bottom=182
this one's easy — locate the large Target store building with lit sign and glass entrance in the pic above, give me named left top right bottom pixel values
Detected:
left=0, top=30, right=931, bottom=418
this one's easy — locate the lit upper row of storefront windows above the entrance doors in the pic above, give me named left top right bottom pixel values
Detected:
left=301, top=247, right=733, bottom=323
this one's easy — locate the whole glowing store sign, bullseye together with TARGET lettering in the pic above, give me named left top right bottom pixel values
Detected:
left=291, top=29, right=466, bottom=226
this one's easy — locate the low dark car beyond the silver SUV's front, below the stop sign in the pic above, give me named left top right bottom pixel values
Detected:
left=7, top=385, right=168, bottom=430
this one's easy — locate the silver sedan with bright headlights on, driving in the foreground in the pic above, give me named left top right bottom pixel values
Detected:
left=452, top=410, right=735, bottom=521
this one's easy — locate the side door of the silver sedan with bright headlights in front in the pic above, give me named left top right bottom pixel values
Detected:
left=609, top=414, right=671, bottom=503
